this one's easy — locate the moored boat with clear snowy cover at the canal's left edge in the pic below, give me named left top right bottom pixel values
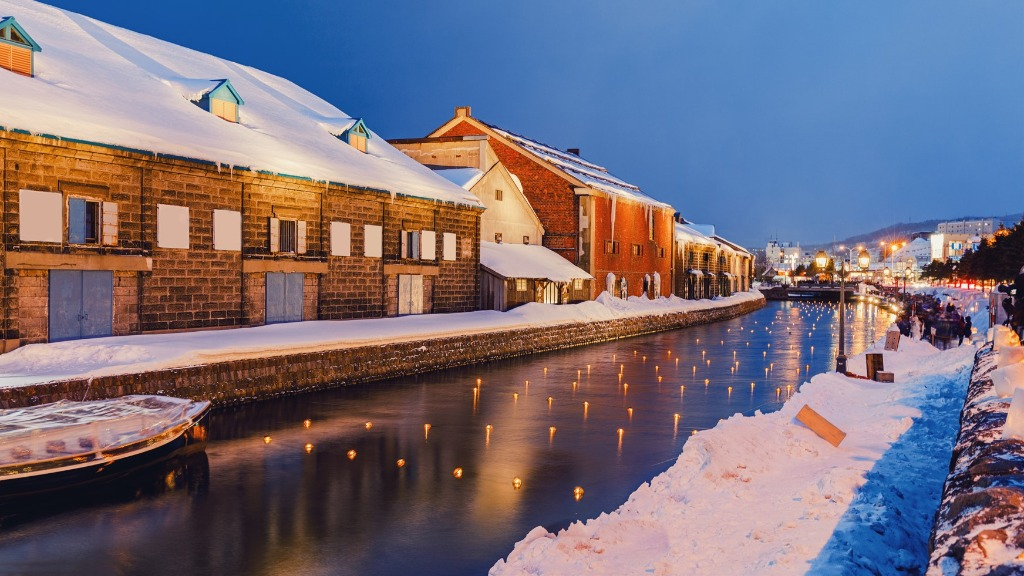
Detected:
left=0, top=396, right=210, bottom=501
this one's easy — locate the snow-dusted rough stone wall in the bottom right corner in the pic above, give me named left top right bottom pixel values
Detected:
left=928, top=344, right=1024, bottom=575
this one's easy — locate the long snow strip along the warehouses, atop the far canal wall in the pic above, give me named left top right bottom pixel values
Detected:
left=0, top=292, right=762, bottom=387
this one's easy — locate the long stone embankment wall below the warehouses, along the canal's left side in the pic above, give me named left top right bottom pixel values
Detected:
left=0, top=299, right=765, bottom=408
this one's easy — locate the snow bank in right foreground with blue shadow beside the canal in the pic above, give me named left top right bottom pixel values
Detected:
left=490, top=291, right=988, bottom=576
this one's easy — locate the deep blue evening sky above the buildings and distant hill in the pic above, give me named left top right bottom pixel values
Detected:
left=41, top=0, right=1024, bottom=248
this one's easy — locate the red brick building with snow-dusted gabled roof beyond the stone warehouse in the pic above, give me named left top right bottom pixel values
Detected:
left=429, top=107, right=675, bottom=296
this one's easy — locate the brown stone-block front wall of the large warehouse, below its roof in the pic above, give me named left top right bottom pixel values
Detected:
left=0, top=131, right=479, bottom=340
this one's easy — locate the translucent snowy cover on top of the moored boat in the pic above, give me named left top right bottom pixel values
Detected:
left=0, top=396, right=210, bottom=465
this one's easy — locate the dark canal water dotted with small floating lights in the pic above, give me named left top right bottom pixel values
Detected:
left=0, top=302, right=892, bottom=575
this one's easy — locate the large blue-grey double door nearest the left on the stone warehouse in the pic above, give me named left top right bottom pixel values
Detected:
left=49, top=270, right=114, bottom=342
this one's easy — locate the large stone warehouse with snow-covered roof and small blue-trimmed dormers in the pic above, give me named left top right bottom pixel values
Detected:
left=0, top=1, right=482, bottom=349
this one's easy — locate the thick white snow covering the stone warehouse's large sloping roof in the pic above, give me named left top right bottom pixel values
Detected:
left=0, top=0, right=481, bottom=206
